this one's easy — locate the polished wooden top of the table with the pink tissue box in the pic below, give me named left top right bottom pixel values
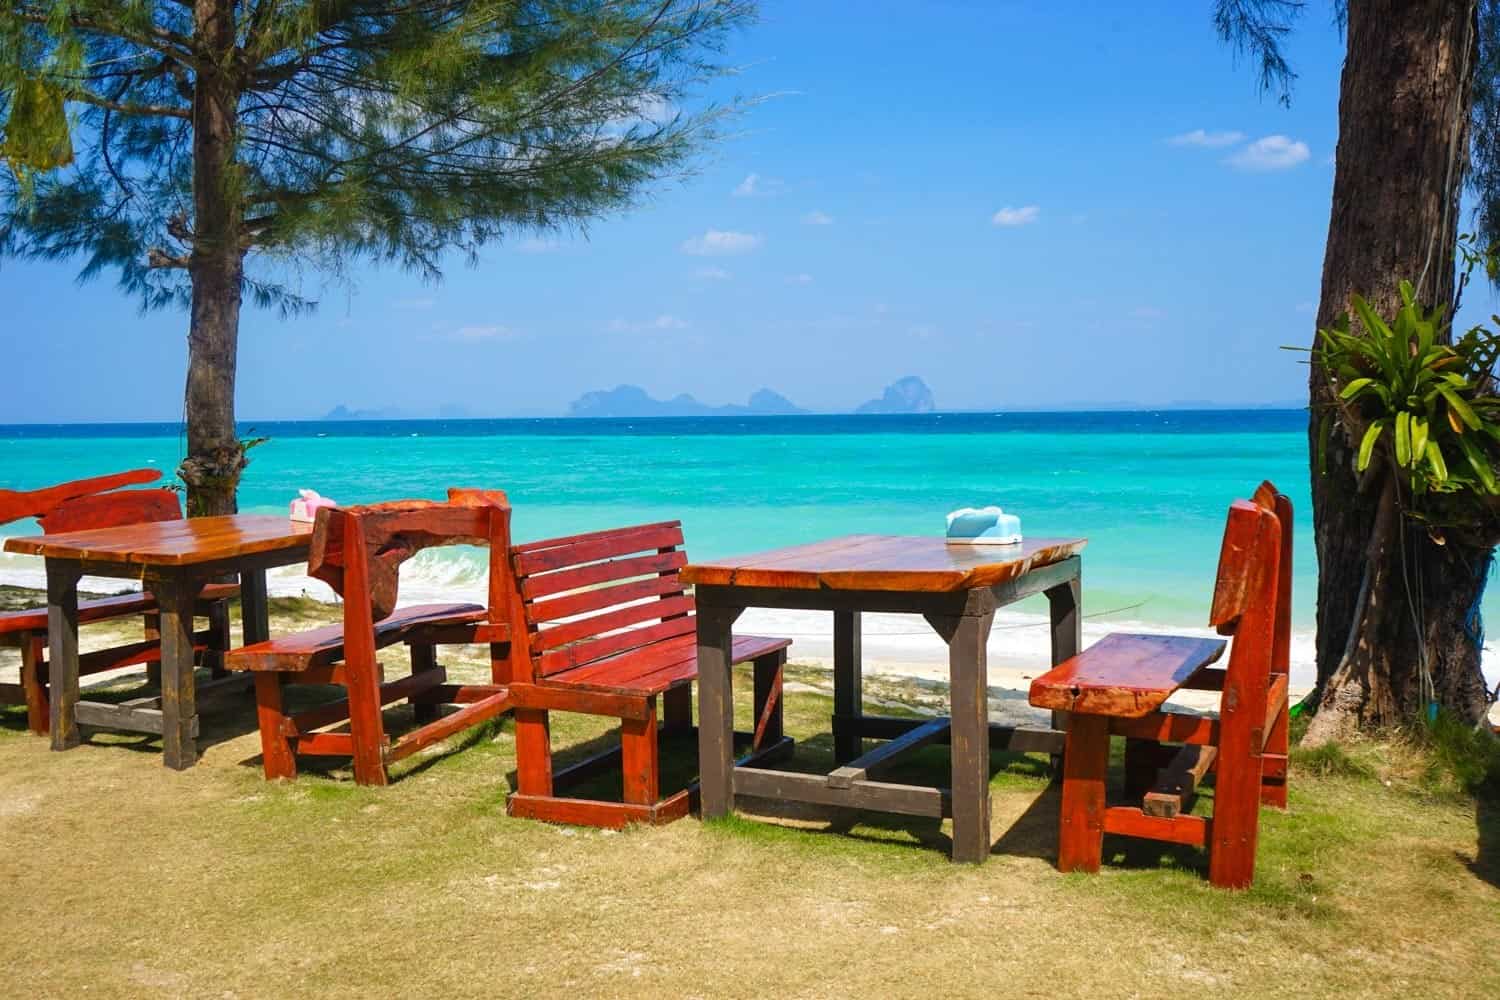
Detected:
left=5, top=514, right=312, bottom=567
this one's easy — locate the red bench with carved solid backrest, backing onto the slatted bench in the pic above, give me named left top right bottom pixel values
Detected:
left=225, top=490, right=510, bottom=784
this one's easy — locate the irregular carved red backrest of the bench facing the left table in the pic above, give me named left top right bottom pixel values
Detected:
left=308, top=489, right=510, bottom=620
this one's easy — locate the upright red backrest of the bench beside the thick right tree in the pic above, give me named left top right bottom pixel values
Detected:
left=1209, top=483, right=1292, bottom=754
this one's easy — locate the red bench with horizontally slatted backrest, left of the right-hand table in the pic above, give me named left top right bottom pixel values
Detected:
left=506, top=522, right=791, bottom=828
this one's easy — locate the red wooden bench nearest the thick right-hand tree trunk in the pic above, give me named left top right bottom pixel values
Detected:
left=1031, top=483, right=1292, bottom=889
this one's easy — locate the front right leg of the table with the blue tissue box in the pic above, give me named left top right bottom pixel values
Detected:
left=927, top=612, right=995, bottom=864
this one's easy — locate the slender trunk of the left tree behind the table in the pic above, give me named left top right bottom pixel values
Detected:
left=177, top=0, right=245, bottom=516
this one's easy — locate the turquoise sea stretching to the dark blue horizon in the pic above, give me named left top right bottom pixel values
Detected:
left=0, top=411, right=1496, bottom=680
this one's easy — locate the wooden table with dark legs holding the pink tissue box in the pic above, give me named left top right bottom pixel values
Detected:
left=5, top=514, right=312, bottom=771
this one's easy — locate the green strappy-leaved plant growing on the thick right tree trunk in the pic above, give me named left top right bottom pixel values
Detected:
left=1313, top=275, right=1500, bottom=521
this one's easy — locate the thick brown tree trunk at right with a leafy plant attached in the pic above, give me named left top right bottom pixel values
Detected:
left=1308, top=0, right=1490, bottom=742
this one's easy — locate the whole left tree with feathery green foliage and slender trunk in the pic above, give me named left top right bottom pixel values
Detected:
left=0, top=0, right=755, bottom=513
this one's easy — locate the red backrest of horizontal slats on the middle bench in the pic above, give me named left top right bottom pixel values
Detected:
left=510, top=520, right=695, bottom=679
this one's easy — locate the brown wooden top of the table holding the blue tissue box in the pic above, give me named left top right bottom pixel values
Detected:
left=683, top=535, right=1088, bottom=594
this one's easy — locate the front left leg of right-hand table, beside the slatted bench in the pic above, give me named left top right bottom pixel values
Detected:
left=698, top=606, right=743, bottom=820
